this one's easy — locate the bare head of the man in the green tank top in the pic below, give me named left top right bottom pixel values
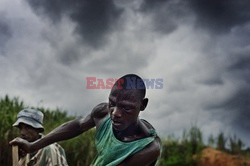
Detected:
left=109, top=74, right=148, bottom=131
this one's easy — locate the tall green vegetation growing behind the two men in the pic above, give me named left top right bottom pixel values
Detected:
left=0, top=96, right=250, bottom=166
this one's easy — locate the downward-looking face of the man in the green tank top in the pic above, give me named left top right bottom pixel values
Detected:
left=109, top=89, right=142, bottom=131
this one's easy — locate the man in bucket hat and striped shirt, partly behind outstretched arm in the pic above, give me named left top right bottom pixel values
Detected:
left=13, top=109, right=68, bottom=166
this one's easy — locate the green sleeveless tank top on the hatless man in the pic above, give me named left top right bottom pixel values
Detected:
left=91, top=117, right=156, bottom=166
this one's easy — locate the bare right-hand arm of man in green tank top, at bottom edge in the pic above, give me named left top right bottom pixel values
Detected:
left=119, top=138, right=161, bottom=166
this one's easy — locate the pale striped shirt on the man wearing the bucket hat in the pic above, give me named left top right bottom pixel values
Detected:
left=19, top=143, right=68, bottom=166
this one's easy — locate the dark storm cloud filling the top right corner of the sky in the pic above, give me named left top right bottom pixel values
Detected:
left=189, top=0, right=250, bottom=33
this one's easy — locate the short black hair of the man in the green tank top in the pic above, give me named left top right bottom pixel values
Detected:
left=112, top=74, right=146, bottom=99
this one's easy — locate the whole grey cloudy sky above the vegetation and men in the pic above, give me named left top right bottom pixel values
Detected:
left=0, top=0, right=250, bottom=145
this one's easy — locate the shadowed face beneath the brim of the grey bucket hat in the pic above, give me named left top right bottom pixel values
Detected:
left=18, top=123, right=39, bottom=142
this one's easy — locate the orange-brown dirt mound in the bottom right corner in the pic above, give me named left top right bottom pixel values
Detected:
left=195, top=147, right=250, bottom=166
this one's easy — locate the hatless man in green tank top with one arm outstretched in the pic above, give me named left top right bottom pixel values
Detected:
left=10, top=74, right=161, bottom=166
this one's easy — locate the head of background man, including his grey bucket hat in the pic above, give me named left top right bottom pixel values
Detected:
left=13, top=109, right=44, bottom=142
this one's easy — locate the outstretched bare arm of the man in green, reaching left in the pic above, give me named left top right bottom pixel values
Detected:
left=10, top=104, right=108, bottom=153
